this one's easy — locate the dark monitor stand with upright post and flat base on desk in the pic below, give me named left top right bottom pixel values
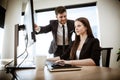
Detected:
left=5, top=24, right=35, bottom=80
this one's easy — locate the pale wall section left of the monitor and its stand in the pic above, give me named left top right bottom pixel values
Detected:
left=2, top=0, right=22, bottom=59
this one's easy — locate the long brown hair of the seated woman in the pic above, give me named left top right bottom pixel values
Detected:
left=70, top=17, right=94, bottom=59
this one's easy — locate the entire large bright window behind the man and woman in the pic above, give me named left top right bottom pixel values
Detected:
left=36, top=6, right=99, bottom=55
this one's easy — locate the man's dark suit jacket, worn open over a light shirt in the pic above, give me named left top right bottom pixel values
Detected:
left=37, top=20, right=74, bottom=53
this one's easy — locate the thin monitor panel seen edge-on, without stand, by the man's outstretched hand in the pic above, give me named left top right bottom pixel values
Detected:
left=24, top=0, right=36, bottom=46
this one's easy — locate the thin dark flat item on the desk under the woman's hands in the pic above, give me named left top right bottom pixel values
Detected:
left=46, top=61, right=81, bottom=72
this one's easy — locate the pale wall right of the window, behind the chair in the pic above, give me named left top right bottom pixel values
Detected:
left=97, top=0, right=120, bottom=68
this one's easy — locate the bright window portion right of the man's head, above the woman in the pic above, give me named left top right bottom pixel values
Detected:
left=67, top=6, right=99, bottom=38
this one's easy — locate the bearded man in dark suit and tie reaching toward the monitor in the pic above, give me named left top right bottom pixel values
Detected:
left=35, top=6, right=74, bottom=59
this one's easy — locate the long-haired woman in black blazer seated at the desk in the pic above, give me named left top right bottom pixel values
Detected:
left=56, top=17, right=100, bottom=66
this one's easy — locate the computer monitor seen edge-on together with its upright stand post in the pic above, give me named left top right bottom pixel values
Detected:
left=14, top=0, right=36, bottom=66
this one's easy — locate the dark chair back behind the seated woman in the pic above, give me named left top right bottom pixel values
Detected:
left=101, top=47, right=113, bottom=67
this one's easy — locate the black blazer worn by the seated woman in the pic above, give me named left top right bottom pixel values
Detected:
left=61, top=38, right=101, bottom=66
